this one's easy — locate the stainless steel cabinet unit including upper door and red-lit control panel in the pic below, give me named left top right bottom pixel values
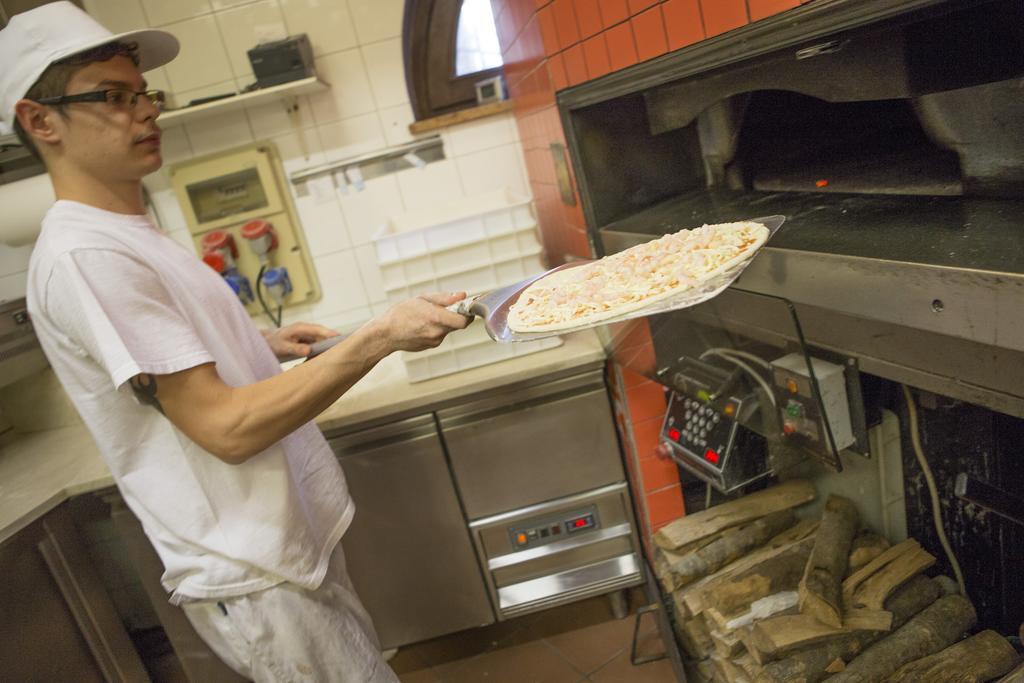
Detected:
left=437, top=370, right=643, bottom=618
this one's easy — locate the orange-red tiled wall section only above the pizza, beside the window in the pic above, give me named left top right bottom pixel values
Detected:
left=490, top=0, right=808, bottom=265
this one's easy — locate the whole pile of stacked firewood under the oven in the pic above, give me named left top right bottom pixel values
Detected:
left=654, top=480, right=1024, bottom=683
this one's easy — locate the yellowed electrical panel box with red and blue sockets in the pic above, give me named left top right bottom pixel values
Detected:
left=170, top=142, right=321, bottom=315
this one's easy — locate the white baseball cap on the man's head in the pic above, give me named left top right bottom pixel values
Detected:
left=0, top=0, right=178, bottom=125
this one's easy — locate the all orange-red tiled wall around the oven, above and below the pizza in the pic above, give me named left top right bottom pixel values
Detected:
left=490, top=0, right=810, bottom=549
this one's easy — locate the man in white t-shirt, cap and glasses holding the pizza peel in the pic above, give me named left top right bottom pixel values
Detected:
left=0, top=2, right=467, bottom=683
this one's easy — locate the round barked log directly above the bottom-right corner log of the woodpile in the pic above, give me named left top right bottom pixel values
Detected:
left=825, top=595, right=978, bottom=683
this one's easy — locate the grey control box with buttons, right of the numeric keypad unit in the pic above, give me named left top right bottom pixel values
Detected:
left=771, top=353, right=856, bottom=451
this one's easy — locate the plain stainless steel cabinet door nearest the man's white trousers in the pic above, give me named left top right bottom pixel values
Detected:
left=331, top=416, right=495, bottom=649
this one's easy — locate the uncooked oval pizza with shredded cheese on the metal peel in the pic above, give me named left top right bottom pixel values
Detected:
left=508, top=221, right=769, bottom=333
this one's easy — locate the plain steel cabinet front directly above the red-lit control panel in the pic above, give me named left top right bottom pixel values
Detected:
left=437, top=371, right=626, bottom=519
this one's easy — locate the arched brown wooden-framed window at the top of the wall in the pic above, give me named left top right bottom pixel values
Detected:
left=402, top=0, right=502, bottom=121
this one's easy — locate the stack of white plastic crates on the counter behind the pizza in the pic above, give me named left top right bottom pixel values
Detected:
left=374, top=190, right=562, bottom=382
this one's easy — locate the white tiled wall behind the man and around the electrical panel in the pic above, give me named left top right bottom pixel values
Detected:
left=0, top=0, right=528, bottom=335
